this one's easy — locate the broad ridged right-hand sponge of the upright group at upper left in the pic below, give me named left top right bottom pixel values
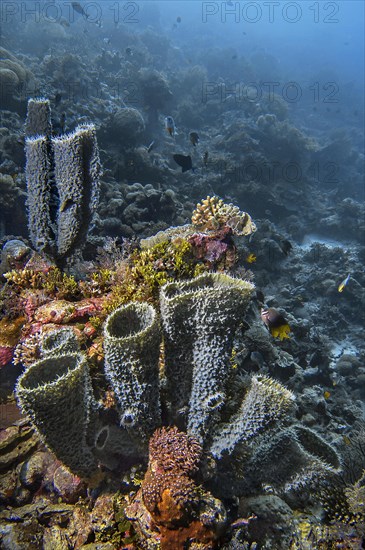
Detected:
left=52, top=124, right=100, bottom=258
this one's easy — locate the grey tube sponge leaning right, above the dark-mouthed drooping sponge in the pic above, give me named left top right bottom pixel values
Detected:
left=210, top=376, right=294, bottom=459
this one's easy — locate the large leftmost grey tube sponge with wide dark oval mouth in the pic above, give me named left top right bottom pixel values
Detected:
left=16, top=353, right=97, bottom=477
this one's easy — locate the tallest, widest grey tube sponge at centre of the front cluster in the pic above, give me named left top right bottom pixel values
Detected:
left=160, top=273, right=254, bottom=442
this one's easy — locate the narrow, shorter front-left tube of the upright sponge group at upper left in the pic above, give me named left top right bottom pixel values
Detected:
left=25, top=136, right=55, bottom=255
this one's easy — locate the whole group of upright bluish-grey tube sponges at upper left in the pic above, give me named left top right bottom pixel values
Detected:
left=25, top=99, right=101, bottom=259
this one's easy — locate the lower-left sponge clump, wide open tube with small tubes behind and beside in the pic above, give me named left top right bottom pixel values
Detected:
left=16, top=328, right=138, bottom=477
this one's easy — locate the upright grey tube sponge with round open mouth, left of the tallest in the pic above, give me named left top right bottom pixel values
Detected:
left=104, top=302, right=161, bottom=439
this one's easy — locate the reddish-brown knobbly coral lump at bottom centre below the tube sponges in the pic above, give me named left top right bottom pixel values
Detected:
left=126, top=427, right=227, bottom=550
